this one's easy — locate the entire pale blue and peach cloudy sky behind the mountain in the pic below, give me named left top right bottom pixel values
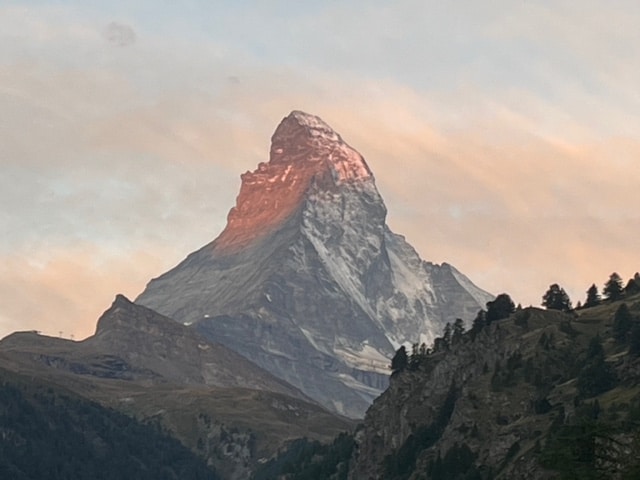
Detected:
left=0, top=0, right=640, bottom=339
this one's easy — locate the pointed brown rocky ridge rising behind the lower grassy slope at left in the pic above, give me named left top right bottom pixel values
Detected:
left=0, top=295, right=311, bottom=401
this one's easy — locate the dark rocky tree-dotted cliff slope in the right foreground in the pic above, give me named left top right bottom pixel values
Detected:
left=350, top=296, right=640, bottom=480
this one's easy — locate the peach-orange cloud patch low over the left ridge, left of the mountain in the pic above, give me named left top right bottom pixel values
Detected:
left=0, top=244, right=172, bottom=339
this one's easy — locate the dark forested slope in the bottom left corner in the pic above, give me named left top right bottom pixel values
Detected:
left=0, top=370, right=219, bottom=480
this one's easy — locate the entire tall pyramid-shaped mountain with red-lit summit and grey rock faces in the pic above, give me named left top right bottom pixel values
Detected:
left=136, top=111, right=492, bottom=418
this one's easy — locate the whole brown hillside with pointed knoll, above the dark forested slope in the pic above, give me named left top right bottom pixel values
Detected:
left=0, top=295, right=352, bottom=480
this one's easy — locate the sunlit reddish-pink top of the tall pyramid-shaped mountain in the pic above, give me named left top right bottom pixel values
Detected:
left=215, top=110, right=373, bottom=252
